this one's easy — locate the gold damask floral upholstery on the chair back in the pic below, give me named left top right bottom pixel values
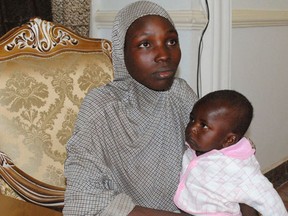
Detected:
left=0, top=52, right=113, bottom=196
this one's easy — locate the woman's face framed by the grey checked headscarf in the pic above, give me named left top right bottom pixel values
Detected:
left=124, top=15, right=181, bottom=91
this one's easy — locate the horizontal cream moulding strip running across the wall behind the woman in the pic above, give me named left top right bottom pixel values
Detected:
left=93, top=10, right=288, bottom=30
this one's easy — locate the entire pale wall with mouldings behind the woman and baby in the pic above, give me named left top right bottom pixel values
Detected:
left=90, top=0, right=288, bottom=172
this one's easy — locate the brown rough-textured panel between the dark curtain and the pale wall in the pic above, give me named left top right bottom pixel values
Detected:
left=51, top=0, right=91, bottom=37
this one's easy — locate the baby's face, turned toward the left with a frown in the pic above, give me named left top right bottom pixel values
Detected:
left=185, top=103, right=232, bottom=153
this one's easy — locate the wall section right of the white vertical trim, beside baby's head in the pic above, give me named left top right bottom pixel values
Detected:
left=231, top=0, right=288, bottom=172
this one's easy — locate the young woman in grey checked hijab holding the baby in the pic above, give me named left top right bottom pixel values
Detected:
left=63, top=1, right=260, bottom=216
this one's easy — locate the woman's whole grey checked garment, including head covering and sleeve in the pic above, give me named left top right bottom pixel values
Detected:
left=63, top=1, right=197, bottom=216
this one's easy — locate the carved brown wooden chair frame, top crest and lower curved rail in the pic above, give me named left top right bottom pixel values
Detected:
left=0, top=18, right=111, bottom=210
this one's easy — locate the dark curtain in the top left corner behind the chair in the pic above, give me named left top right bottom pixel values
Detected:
left=0, top=0, right=52, bottom=37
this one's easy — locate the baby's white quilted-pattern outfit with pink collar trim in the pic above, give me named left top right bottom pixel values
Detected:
left=174, top=138, right=288, bottom=216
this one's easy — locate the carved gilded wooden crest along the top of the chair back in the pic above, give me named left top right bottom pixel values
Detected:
left=0, top=18, right=112, bottom=60
